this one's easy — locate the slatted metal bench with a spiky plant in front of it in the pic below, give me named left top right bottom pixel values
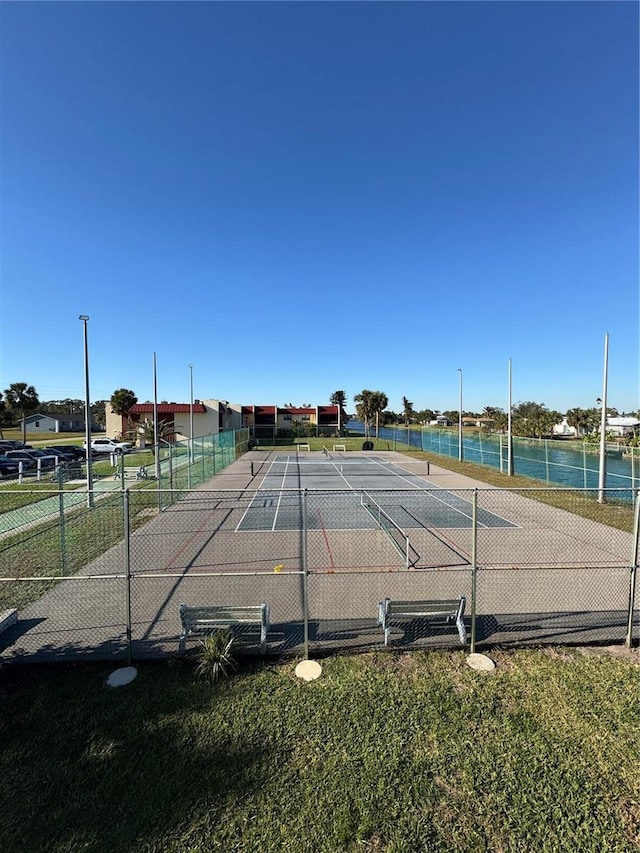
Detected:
left=179, top=604, right=269, bottom=654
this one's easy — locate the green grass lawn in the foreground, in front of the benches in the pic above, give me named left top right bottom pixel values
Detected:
left=0, top=649, right=640, bottom=853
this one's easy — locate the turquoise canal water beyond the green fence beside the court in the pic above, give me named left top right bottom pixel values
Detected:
left=348, top=421, right=640, bottom=489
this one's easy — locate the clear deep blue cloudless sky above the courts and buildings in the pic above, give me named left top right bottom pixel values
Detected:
left=0, top=2, right=640, bottom=412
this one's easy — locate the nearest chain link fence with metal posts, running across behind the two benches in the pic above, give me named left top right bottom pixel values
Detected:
left=0, top=482, right=640, bottom=661
